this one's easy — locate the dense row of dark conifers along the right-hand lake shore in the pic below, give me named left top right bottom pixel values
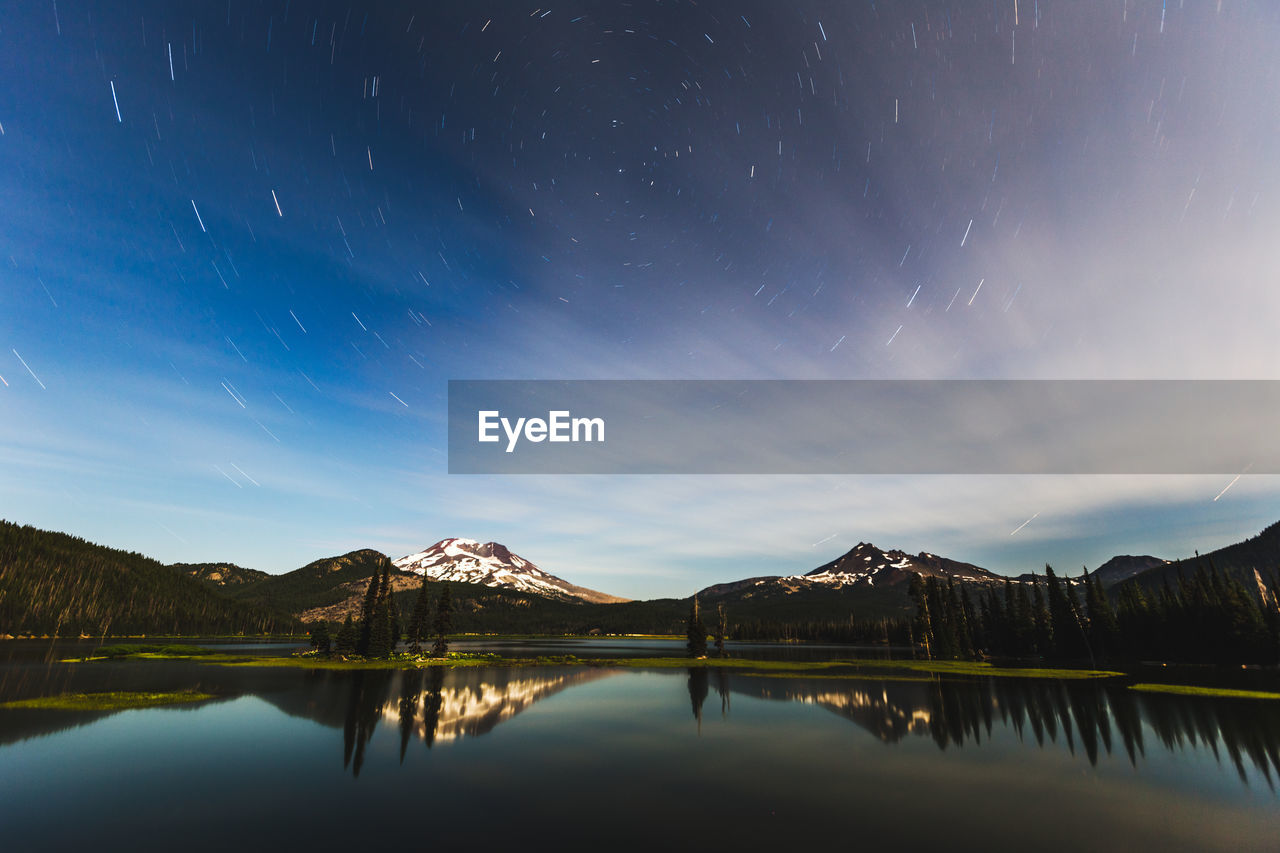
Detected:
left=909, top=562, right=1280, bottom=663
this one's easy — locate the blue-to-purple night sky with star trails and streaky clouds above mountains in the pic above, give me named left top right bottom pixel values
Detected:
left=0, top=0, right=1280, bottom=597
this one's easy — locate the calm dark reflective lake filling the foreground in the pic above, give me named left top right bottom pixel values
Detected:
left=0, top=640, right=1280, bottom=850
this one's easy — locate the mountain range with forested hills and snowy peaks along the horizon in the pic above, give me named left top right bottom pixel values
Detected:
left=0, top=512, right=1280, bottom=637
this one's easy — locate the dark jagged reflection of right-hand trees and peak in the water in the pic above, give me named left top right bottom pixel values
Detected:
left=731, top=676, right=1280, bottom=786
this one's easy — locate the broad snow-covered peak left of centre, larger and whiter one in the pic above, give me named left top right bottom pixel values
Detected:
left=393, top=539, right=627, bottom=605
